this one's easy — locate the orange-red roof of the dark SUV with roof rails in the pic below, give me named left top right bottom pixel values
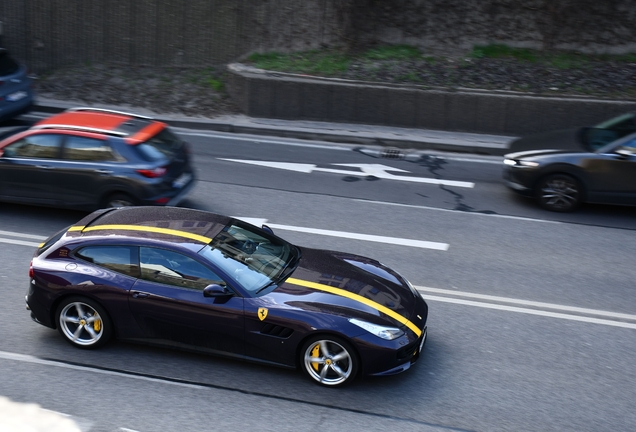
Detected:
left=31, top=107, right=167, bottom=144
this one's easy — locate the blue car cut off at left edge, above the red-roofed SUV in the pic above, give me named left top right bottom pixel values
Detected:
left=0, top=48, right=33, bottom=122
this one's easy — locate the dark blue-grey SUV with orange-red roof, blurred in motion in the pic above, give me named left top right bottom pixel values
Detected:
left=0, top=108, right=195, bottom=210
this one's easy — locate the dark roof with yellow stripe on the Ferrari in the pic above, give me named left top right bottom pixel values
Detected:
left=67, top=207, right=233, bottom=245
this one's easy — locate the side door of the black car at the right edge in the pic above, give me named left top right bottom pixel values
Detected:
left=586, top=138, right=636, bottom=205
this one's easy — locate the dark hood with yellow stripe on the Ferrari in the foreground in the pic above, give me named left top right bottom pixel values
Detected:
left=272, top=248, right=421, bottom=326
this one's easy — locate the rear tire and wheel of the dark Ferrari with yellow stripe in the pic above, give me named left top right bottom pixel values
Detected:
left=55, top=297, right=113, bottom=349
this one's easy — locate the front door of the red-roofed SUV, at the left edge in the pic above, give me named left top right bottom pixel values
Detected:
left=0, top=133, right=62, bottom=204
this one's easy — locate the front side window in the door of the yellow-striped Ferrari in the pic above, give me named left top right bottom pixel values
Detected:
left=139, top=247, right=225, bottom=291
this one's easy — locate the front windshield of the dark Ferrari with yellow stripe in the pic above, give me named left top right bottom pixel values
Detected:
left=199, top=223, right=299, bottom=294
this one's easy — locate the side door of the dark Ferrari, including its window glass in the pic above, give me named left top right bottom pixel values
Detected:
left=128, top=246, right=245, bottom=356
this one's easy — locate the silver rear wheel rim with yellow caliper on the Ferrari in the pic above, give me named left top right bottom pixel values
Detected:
left=58, top=301, right=104, bottom=347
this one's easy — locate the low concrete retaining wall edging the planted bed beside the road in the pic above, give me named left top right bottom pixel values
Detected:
left=228, top=64, right=636, bottom=135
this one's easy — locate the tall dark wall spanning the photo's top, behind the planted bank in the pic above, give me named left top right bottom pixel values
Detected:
left=0, top=0, right=636, bottom=71
